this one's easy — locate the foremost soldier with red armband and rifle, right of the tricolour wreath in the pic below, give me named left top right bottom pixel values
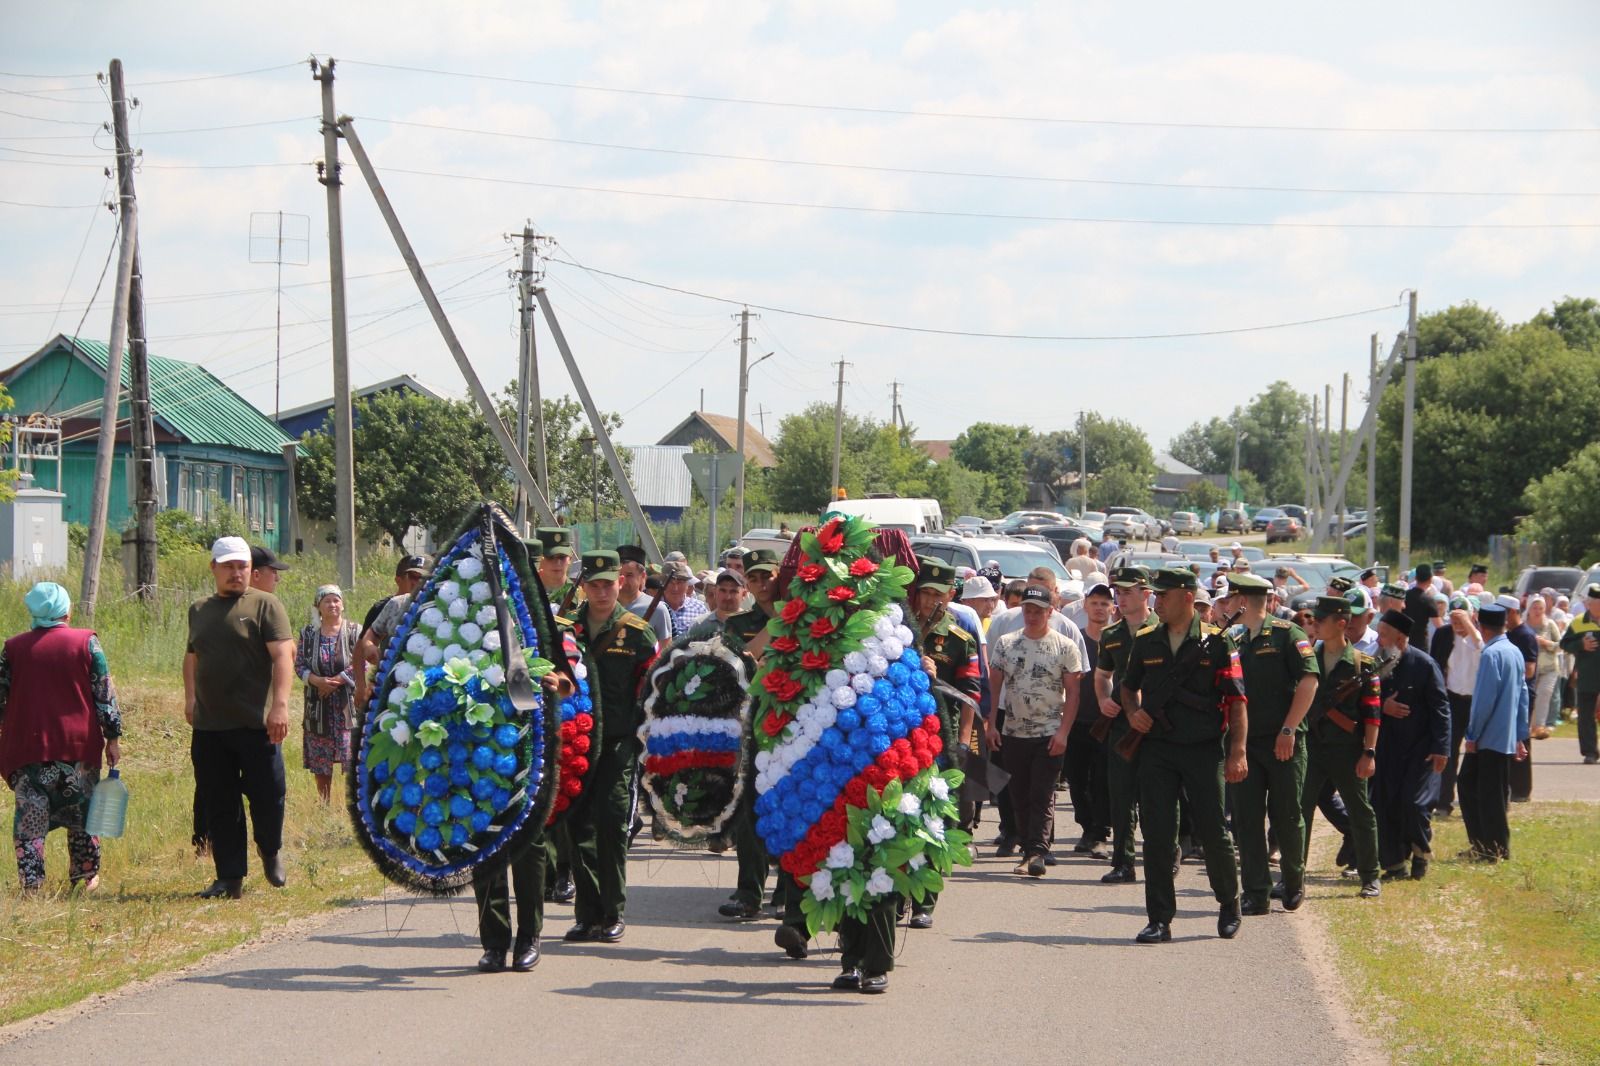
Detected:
left=1122, top=570, right=1250, bottom=944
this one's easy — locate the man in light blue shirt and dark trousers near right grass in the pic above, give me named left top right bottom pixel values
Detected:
left=1456, top=603, right=1528, bottom=863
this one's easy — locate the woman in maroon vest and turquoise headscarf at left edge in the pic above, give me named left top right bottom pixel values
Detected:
left=0, top=581, right=122, bottom=893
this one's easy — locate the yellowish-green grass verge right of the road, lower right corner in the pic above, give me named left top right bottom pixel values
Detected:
left=1317, top=804, right=1600, bottom=1066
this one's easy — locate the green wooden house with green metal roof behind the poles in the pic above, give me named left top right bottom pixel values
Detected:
left=0, top=335, right=294, bottom=552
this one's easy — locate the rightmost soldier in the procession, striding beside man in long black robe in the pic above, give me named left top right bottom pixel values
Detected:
left=1305, top=595, right=1382, bottom=900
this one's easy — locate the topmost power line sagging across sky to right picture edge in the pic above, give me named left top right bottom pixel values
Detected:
left=341, top=59, right=1600, bottom=134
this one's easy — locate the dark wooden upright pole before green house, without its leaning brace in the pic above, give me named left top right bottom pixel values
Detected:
left=110, top=59, right=155, bottom=600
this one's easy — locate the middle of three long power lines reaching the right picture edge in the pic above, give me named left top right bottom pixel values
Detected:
left=358, top=115, right=1600, bottom=197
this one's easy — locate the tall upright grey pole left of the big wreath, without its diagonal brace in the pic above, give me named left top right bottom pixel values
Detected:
left=310, top=58, right=355, bottom=595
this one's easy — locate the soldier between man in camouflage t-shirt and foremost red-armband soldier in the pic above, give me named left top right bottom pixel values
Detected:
left=1078, top=567, right=1150, bottom=885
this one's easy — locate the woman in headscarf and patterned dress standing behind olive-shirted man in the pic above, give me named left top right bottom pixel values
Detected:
left=294, top=584, right=362, bottom=804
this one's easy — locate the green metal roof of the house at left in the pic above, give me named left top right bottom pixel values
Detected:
left=61, top=335, right=294, bottom=455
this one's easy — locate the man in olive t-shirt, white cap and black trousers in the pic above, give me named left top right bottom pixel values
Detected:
left=184, top=536, right=294, bottom=900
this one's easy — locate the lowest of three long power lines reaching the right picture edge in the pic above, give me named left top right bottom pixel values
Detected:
left=363, top=166, right=1600, bottom=230
